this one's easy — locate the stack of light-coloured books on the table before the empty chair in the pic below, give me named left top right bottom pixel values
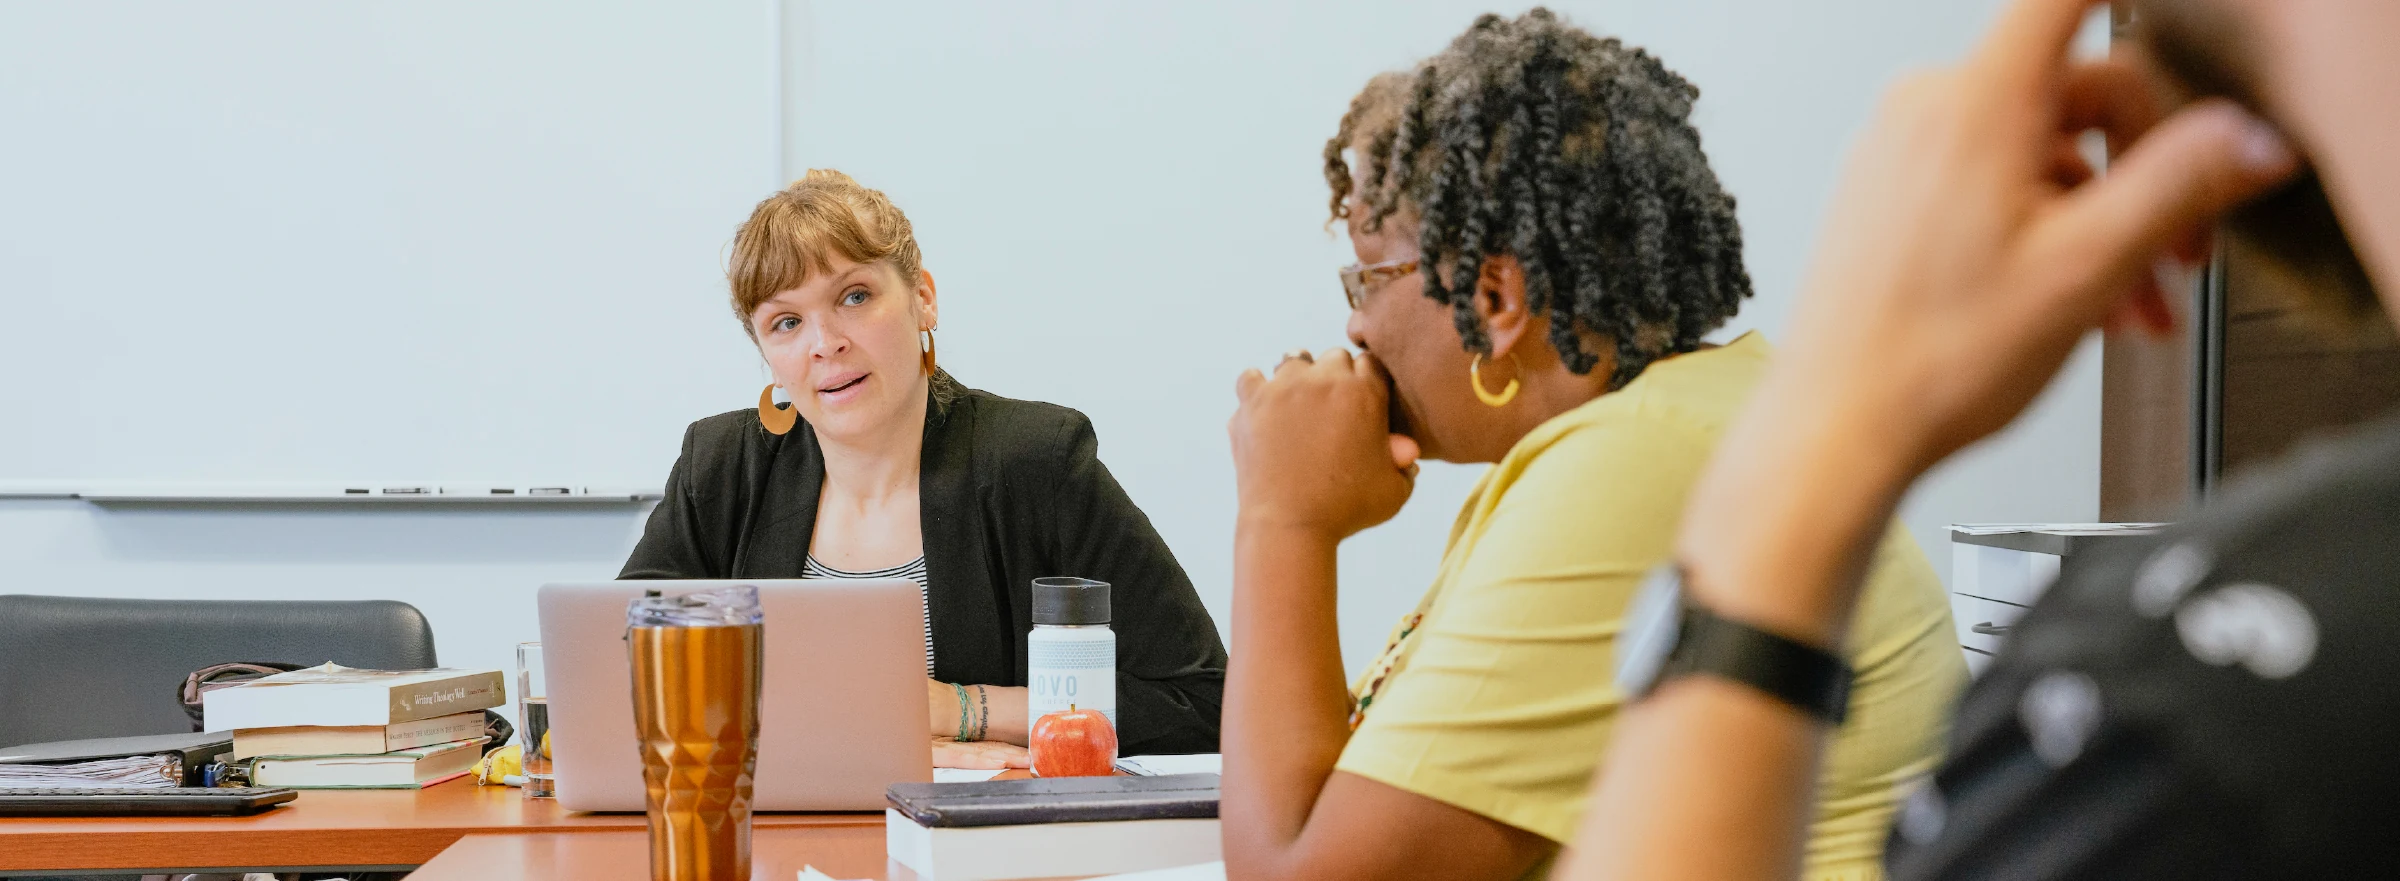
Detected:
left=202, top=665, right=504, bottom=790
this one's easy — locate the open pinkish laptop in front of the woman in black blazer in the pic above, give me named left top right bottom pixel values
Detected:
left=538, top=579, right=934, bottom=811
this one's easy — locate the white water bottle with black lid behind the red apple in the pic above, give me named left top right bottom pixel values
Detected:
left=1025, top=579, right=1118, bottom=737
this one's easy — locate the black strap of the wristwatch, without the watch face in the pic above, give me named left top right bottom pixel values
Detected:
left=1658, top=605, right=1850, bottom=725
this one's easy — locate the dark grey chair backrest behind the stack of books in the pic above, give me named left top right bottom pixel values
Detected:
left=0, top=595, right=437, bottom=747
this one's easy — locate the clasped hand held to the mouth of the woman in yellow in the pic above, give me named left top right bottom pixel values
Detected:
left=1226, top=348, right=1416, bottom=540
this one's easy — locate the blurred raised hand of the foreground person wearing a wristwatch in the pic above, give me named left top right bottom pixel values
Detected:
left=1750, top=0, right=2297, bottom=473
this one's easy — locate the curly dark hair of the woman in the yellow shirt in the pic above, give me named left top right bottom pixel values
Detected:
left=1325, top=7, right=1750, bottom=389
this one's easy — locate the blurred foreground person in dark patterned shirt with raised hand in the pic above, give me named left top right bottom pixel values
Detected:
left=1536, top=0, right=2400, bottom=879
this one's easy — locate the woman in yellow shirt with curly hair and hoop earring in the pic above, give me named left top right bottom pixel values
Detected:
left=1222, top=10, right=1966, bottom=879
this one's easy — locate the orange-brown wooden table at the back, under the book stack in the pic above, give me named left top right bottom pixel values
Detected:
left=0, top=780, right=883, bottom=879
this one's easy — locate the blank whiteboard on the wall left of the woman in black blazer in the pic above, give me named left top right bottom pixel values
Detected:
left=0, top=0, right=782, bottom=487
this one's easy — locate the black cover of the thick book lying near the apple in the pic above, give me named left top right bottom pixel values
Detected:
left=883, top=773, right=1217, bottom=828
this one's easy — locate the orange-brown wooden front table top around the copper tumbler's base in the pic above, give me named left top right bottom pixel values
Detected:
left=408, top=823, right=917, bottom=881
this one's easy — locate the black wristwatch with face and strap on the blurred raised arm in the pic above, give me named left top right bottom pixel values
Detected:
left=1618, top=564, right=1850, bottom=725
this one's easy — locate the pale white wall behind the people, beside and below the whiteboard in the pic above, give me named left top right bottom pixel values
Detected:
left=0, top=0, right=2098, bottom=691
